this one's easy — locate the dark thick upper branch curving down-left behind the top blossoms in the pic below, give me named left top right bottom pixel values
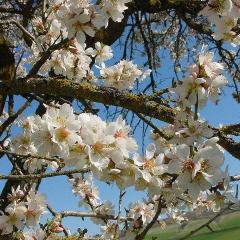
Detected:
left=23, top=0, right=206, bottom=76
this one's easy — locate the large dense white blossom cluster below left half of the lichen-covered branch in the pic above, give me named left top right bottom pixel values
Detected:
left=11, top=104, right=137, bottom=173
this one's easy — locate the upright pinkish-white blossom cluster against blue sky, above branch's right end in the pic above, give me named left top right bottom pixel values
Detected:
left=172, top=46, right=227, bottom=109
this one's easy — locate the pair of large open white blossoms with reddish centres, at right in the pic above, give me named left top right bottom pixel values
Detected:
left=167, top=140, right=224, bottom=200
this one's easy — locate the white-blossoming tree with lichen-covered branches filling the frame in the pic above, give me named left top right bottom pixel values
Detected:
left=0, top=0, right=240, bottom=240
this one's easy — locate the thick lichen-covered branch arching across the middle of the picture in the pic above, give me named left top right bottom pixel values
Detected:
left=0, top=77, right=240, bottom=159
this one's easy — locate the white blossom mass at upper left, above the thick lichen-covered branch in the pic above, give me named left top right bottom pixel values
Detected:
left=19, top=0, right=150, bottom=90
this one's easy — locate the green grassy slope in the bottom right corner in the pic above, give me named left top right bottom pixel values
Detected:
left=145, top=212, right=240, bottom=240
